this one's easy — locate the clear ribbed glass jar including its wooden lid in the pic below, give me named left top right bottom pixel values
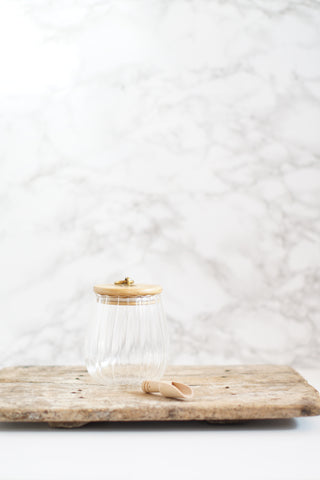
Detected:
left=86, top=278, right=168, bottom=385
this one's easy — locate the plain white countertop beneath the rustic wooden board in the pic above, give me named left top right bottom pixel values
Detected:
left=0, top=369, right=320, bottom=480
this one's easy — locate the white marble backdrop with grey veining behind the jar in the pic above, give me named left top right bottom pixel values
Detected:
left=0, top=0, right=320, bottom=367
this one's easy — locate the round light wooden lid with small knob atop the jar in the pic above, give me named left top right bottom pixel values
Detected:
left=93, top=277, right=162, bottom=297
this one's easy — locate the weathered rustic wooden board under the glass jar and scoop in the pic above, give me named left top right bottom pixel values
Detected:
left=0, top=365, right=320, bottom=427
